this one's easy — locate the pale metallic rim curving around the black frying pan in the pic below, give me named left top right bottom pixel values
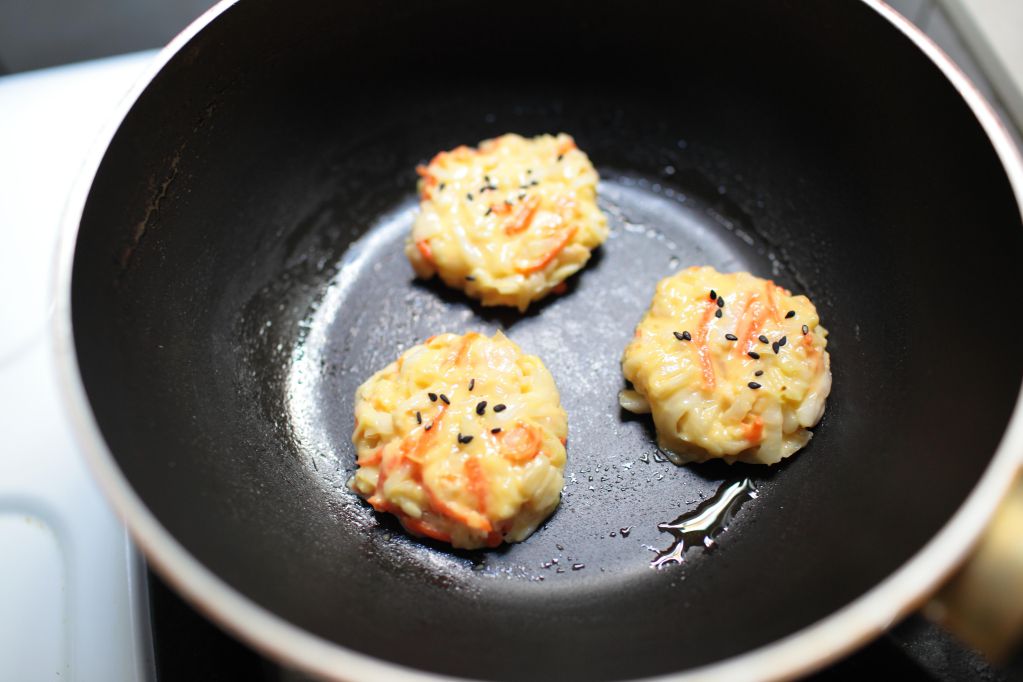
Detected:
left=50, top=0, right=1023, bottom=682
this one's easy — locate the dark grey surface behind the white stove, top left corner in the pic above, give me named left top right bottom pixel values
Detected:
left=0, top=0, right=215, bottom=74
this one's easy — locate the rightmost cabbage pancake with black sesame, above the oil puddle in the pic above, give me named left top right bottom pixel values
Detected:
left=620, top=267, right=831, bottom=464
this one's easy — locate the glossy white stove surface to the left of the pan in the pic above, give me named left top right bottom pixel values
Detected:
left=0, top=52, right=154, bottom=682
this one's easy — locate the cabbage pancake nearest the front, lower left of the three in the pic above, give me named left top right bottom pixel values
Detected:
left=350, top=332, right=568, bottom=549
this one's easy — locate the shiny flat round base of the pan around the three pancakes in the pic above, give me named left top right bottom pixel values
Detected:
left=290, top=170, right=782, bottom=580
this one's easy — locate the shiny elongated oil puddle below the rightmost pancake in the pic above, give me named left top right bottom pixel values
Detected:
left=651, top=479, right=757, bottom=569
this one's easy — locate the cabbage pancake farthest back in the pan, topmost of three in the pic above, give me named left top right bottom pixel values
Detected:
left=405, top=134, right=608, bottom=311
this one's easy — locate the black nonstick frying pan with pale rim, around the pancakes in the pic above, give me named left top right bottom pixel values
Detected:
left=58, top=0, right=1023, bottom=680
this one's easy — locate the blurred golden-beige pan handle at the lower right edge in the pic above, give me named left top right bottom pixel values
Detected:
left=924, top=474, right=1023, bottom=664
